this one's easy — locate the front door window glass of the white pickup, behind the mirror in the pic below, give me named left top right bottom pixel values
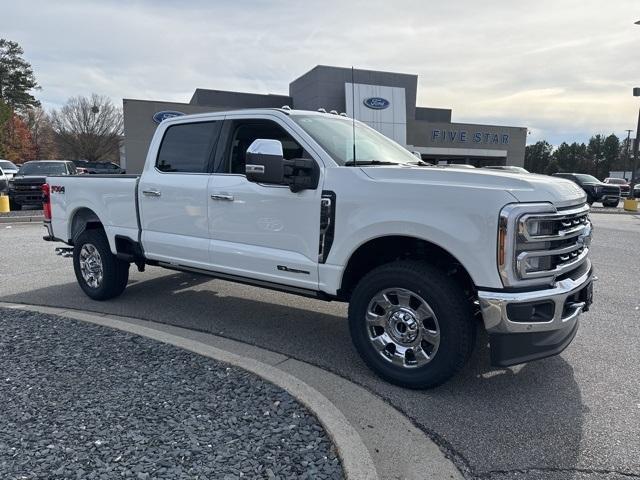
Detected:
left=221, top=119, right=309, bottom=175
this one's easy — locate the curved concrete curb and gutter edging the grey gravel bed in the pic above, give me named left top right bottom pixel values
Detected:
left=0, top=302, right=463, bottom=480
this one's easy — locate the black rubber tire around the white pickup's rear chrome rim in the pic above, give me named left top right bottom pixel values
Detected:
left=73, top=229, right=129, bottom=300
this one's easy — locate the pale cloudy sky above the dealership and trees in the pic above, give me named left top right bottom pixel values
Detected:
left=0, top=0, right=640, bottom=145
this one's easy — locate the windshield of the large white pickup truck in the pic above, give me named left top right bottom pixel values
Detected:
left=291, top=115, right=420, bottom=166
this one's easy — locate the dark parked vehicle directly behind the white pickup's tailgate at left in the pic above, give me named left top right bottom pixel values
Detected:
left=9, top=160, right=77, bottom=210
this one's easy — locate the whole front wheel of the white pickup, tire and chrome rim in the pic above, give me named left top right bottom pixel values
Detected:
left=349, top=261, right=475, bottom=388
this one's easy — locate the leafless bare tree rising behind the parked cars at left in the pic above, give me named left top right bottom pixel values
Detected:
left=51, top=93, right=123, bottom=161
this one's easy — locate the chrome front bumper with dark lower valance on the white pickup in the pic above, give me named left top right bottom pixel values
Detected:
left=478, top=265, right=594, bottom=366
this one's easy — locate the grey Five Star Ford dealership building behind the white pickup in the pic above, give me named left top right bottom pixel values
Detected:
left=123, top=65, right=527, bottom=173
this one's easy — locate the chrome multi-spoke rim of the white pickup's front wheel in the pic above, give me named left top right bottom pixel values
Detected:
left=366, top=288, right=440, bottom=368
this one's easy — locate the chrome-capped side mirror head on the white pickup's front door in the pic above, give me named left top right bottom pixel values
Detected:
left=245, top=138, right=284, bottom=184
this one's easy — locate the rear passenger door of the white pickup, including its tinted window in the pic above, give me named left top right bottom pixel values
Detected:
left=138, top=117, right=223, bottom=268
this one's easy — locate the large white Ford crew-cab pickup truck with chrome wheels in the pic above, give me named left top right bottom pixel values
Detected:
left=43, top=108, right=593, bottom=388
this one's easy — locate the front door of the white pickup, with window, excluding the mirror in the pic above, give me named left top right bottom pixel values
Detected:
left=209, top=113, right=322, bottom=290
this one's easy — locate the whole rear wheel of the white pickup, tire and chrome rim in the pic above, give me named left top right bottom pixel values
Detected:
left=73, top=229, right=129, bottom=300
